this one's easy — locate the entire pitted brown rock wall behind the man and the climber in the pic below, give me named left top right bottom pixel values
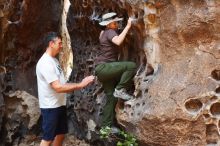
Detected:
left=0, top=0, right=220, bottom=146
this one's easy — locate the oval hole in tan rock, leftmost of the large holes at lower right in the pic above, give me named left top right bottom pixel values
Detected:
left=185, top=99, right=202, bottom=113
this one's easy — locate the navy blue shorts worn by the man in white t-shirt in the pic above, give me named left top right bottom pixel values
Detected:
left=41, top=106, right=68, bottom=141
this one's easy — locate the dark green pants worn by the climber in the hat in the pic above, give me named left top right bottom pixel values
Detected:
left=95, top=61, right=136, bottom=126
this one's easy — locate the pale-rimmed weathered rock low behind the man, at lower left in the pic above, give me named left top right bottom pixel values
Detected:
left=3, top=91, right=40, bottom=144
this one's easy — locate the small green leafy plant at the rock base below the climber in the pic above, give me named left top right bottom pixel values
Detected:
left=100, top=126, right=138, bottom=146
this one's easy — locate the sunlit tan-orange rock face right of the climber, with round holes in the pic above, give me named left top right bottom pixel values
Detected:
left=117, top=0, right=220, bottom=145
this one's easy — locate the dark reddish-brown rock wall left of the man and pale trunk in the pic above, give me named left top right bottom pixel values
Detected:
left=0, top=0, right=62, bottom=145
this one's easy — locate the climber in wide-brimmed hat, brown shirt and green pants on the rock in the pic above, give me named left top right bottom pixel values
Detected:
left=95, top=12, right=136, bottom=128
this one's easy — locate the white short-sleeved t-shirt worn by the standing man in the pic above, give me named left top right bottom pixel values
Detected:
left=36, top=53, right=66, bottom=108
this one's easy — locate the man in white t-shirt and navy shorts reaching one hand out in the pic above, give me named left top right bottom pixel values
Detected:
left=36, top=32, right=94, bottom=146
